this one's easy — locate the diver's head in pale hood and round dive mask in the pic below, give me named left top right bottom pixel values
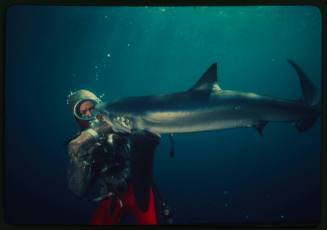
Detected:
left=67, top=89, right=101, bottom=131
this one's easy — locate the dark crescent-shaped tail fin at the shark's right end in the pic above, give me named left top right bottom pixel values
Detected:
left=287, top=59, right=320, bottom=132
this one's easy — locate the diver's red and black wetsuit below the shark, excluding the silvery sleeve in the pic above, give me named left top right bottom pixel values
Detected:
left=91, top=133, right=160, bottom=225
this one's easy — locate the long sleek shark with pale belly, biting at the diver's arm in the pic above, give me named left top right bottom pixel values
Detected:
left=96, top=59, right=320, bottom=135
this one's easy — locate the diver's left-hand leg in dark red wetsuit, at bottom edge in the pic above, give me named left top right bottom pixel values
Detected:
left=91, top=197, right=123, bottom=225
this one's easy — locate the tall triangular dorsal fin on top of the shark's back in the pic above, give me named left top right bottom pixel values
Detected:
left=189, top=63, right=221, bottom=99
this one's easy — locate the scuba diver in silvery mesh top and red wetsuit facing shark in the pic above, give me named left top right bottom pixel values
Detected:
left=67, top=89, right=172, bottom=225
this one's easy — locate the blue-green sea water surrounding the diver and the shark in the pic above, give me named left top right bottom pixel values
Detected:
left=5, top=6, right=321, bottom=224
